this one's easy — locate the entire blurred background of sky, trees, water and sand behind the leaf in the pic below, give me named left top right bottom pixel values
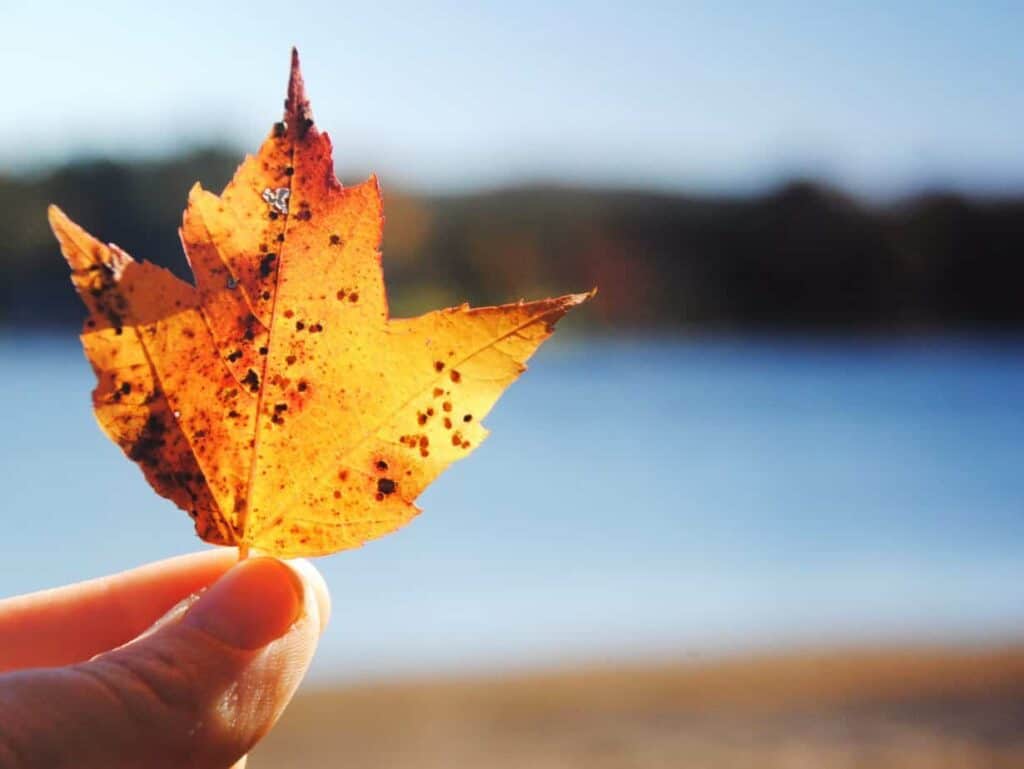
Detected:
left=0, top=0, right=1024, bottom=769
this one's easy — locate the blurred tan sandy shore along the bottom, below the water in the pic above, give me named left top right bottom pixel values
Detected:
left=249, top=645, right=1024, bottom=769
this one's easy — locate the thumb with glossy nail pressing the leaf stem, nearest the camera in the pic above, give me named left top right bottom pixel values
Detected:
left=0, top=558, right=330, bottom=769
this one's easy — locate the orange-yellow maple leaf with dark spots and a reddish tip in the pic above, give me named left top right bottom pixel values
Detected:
left=49, top=50, right=593, bottom=557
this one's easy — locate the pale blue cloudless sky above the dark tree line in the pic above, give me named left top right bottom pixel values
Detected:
left=0, top=0, right=1024, bottom=196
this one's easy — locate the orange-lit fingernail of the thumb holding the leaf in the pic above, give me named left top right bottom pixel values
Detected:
left=182, top=558, right=303, bottom=650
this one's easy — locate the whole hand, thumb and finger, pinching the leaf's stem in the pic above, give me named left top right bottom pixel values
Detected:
left=0, top=550, right=330, bottom=769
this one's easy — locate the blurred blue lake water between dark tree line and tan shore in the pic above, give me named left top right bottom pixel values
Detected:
left=0, top=332, right=1024, bottom=681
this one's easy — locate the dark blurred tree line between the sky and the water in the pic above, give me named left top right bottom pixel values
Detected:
left=0, top=151, right=1024, bottom=330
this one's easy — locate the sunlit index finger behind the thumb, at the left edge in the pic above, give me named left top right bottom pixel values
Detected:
left=0, top=548, right=238, bottom=673
